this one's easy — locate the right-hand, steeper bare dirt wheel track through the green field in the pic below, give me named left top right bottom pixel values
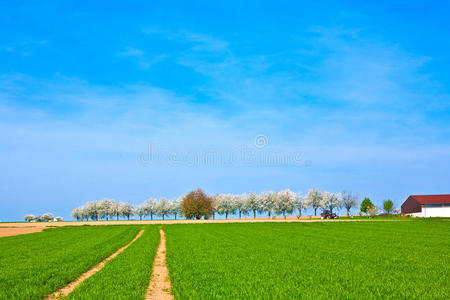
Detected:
left=145, top=229, right=173, bottom=300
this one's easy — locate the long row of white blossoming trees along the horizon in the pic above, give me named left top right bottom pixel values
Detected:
left=72, top=189, right=358, bottom=220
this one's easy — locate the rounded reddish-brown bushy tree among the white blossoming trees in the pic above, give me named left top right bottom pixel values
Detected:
left=181, top=189, right=213, bottom=220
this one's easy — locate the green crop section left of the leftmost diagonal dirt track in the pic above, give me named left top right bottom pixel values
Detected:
left=0, top=225, right=139, bottom=299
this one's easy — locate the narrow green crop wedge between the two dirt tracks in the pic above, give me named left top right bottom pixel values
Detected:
left=67, top=226, right=159, bottom=299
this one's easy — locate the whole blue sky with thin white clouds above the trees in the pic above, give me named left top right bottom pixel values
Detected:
left=0, top=1, right=450, bottom=221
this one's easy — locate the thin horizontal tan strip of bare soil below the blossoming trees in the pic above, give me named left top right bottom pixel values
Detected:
left=0, top=217, right=398, bottom=237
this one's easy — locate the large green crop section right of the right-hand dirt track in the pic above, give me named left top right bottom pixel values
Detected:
left=163, top=220, right=450, bottom=299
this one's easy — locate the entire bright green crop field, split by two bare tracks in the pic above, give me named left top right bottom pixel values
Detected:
left=0, top=219, right=450, bottom=299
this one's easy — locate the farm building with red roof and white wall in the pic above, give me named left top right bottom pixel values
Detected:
left=402, top=195, right=450, bottom=217
